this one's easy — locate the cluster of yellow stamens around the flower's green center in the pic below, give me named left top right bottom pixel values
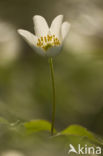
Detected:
left=37, top=35, right=60, bottom=51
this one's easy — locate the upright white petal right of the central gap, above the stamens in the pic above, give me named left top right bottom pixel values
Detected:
left=50, top=15, right=63, bottom=39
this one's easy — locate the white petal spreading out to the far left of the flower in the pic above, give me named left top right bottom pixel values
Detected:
left=18, top=29, right=45, bottom=56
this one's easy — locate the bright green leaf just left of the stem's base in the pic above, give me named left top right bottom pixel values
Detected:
left=24, top=120, right=56, bottom=133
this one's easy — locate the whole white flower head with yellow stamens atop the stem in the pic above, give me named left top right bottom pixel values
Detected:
left=18, top=15, right=70, bottom=57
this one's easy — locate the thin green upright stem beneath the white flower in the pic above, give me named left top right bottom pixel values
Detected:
left=49, top=58, right=55, bottom=135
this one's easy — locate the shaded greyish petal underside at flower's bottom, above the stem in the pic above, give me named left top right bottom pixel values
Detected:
left=46, top=44, right=62, bottom=57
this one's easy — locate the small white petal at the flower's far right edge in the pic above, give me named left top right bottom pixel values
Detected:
left=61, top=22, right=71, bottom=40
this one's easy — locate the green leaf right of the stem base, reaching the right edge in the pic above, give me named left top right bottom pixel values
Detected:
left=60, top=125, right=103, bottom=145
